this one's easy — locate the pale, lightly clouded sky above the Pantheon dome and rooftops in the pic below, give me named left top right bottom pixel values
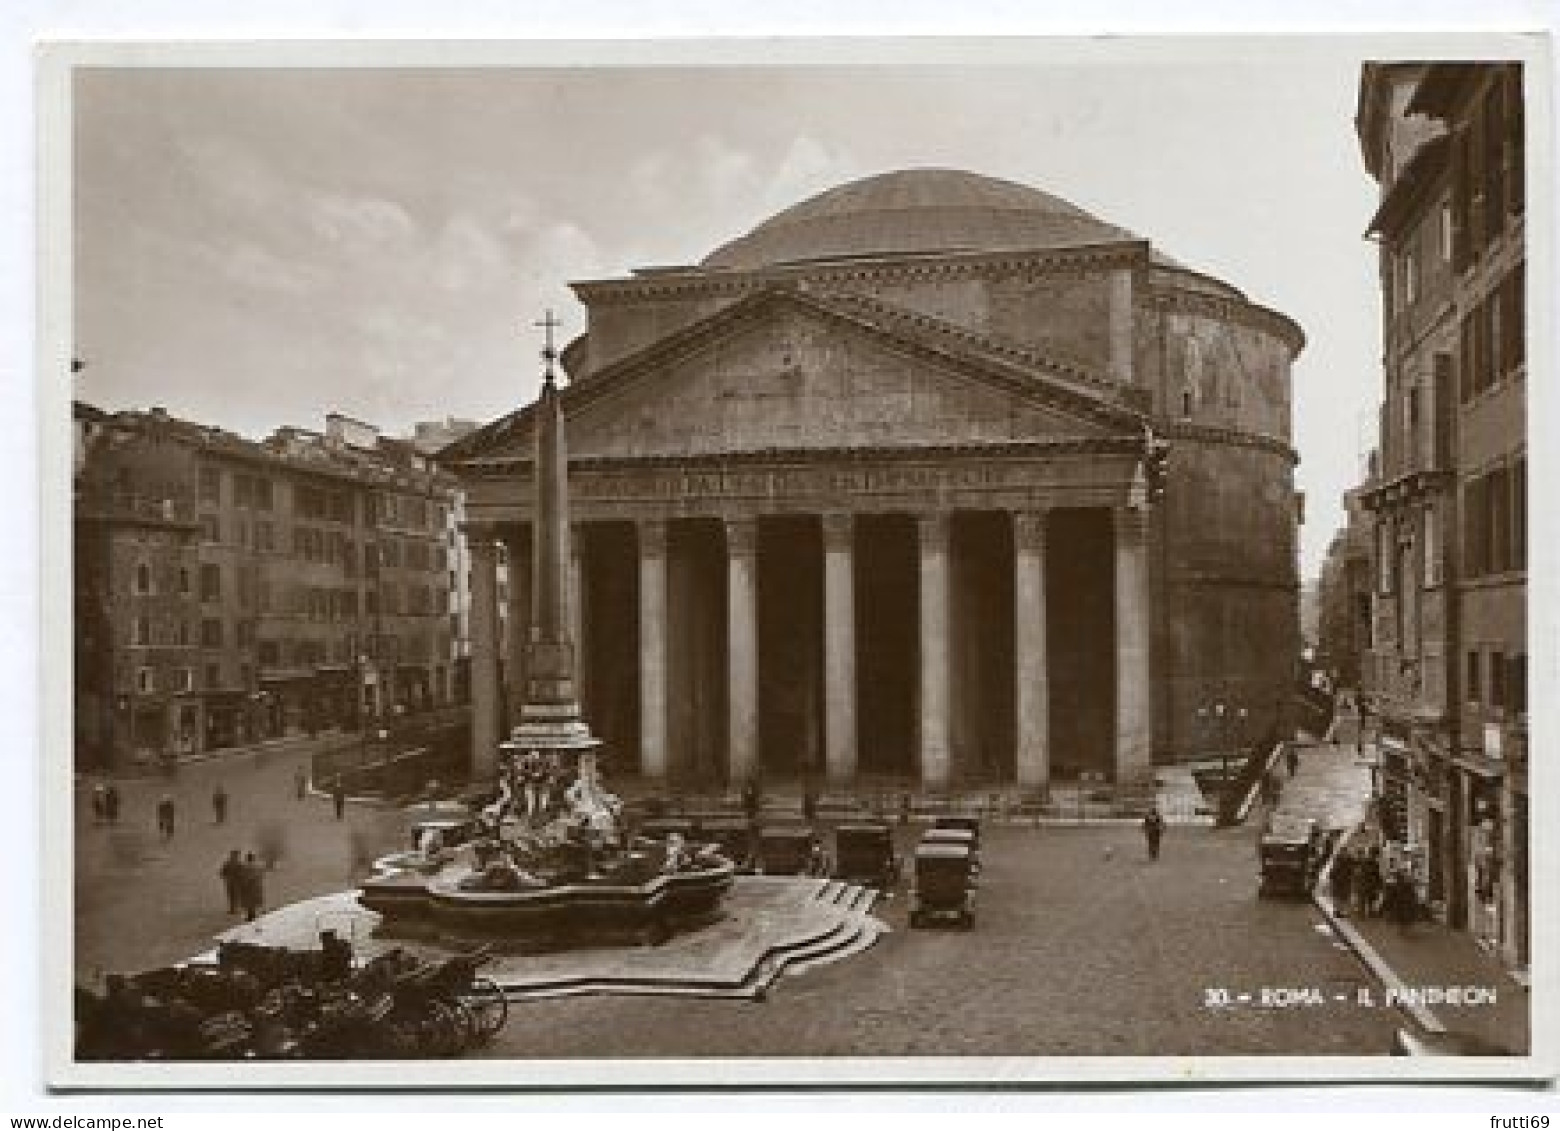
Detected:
left=72, top=41, right=1381, bottom=577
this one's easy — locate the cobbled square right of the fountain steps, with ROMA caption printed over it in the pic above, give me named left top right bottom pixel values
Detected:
left=485, top=825, right=1401, bottom=1058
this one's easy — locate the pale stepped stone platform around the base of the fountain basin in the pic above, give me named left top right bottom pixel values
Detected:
left=197, top=877, right=885, bottom=997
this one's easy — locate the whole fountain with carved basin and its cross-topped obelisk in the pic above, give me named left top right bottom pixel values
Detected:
left=359, top=312, right=735, bottom=948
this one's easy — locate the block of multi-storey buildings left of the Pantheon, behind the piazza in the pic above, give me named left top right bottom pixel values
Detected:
left=75, top=409, right=459, bottom=766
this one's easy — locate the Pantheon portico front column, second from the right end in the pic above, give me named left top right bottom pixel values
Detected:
left=1012, top=512, right=1051, bottom=789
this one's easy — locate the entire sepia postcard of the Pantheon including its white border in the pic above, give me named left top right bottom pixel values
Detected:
left=39, top=34, right=1554, bottom=1089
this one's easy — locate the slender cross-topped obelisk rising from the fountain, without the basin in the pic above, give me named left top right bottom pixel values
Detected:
left=501, top=310, right=601, bottom=753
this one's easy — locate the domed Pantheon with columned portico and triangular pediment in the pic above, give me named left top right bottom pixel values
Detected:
left=441, top=168, right=1304, bottom=791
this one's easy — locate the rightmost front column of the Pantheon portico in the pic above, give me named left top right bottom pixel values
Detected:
left=1111, top=507, right=1151, bottom=782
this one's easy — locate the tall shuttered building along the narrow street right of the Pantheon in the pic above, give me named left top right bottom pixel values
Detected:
left=1356, top=62, right=1529, bottom=966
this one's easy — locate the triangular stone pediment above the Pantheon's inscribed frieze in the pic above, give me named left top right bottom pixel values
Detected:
left=443, top=290, right=1140, bottom=459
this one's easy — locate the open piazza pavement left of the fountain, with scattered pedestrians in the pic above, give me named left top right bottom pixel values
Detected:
left=73, top=744, right=404, bottom=984
